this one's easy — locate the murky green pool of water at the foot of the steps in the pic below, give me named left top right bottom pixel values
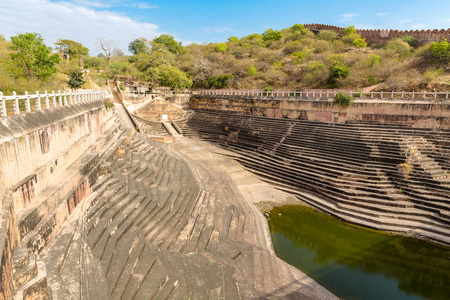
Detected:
left=269, top=206, right=450, bottom=300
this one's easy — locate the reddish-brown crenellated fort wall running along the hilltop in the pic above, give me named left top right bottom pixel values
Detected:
left=304, top=24, right=450, bottom=44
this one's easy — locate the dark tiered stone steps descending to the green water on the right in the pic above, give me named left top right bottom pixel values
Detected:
left=183, top=112, right=450, bottom=243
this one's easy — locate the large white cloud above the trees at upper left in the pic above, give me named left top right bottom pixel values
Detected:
left=0, top=0, right=161, bottom=55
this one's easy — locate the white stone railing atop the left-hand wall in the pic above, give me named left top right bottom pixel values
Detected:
left=0, top=90, right=107, bottom=117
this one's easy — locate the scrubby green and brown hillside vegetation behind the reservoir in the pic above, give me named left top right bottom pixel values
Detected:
left=0, top=24, right=450, bottom=94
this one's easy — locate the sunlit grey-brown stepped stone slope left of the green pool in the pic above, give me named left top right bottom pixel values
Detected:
left=36, top=129, right=336, bottom=300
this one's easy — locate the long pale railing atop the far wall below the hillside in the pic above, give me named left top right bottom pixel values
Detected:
left=191, top=89, right=450, bottom=99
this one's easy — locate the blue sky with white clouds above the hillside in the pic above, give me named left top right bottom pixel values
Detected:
left=0, top=0, right=450, bottom=55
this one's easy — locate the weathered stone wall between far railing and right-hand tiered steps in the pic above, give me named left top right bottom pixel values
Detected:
left=191, top=95, right=450, bottom=128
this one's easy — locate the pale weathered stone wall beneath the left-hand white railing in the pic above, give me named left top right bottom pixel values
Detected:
left=0, top=100, right=115, bottom=299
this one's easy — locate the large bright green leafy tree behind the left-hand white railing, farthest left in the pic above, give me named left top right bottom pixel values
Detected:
left=9, top=33, right=60, bottom=79
